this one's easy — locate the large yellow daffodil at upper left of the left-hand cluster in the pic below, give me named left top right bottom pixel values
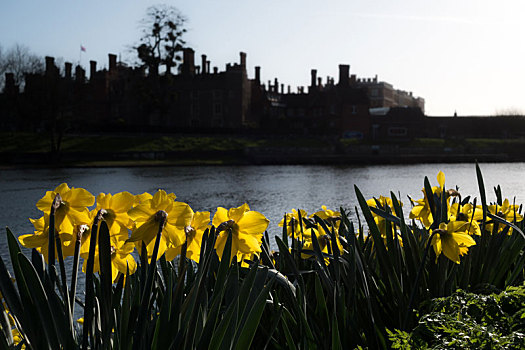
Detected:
left=36, top=183, right=95, bottom=233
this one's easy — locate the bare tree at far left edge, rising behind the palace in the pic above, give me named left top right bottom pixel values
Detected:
left=0, top=44, right=44, bottom=87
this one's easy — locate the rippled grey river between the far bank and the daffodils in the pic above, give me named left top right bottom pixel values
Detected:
left=0, top=163, right=525, bottom=253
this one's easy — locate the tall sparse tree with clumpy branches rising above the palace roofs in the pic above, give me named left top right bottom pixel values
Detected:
left=134, top=5, right=187, bottom=75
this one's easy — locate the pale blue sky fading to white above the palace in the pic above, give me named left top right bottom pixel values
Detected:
left=0, top=0, right=525, bottom=116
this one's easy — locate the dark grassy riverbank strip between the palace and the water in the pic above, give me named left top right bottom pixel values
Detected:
left=0, top=133, right=525, bottom=168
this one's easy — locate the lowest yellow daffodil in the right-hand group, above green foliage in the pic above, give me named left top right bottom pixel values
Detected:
left=431, top=221, right=476, bottom=264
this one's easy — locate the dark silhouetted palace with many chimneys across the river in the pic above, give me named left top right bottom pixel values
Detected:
left=0, top=48, right=525, bottom=140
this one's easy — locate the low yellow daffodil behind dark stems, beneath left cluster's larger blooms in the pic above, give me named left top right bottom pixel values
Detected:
left=80, top=235, right=137, bottom=282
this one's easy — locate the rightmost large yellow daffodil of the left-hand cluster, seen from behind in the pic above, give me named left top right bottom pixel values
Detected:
left=213, top=203, right=269, bottom=261
